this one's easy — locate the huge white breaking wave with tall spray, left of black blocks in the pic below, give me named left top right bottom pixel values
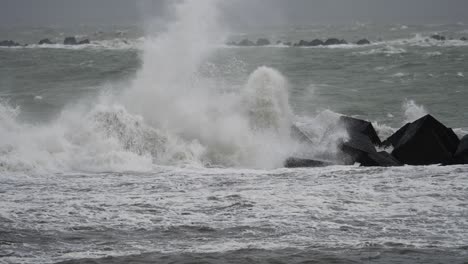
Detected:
left=0, top=0, right=300, bottom=172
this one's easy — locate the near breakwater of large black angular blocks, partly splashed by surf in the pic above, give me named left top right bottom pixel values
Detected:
left=285, top=115, right=468, bottom=167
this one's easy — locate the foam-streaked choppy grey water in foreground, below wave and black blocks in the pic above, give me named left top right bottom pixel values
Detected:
left=0, top=166, right=468, bottom=263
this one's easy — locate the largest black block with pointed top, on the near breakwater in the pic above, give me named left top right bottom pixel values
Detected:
left=388, top=115, right=460, bottom=165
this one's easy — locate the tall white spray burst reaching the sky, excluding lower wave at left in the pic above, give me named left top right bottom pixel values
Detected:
left=121, top=0, right=291, bottom=168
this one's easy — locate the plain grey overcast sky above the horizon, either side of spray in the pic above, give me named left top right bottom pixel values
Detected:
left=0, top=0, right=468, bottom=26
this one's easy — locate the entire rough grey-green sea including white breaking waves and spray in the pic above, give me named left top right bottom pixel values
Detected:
left=0, top=1, right=468, bottom=263
